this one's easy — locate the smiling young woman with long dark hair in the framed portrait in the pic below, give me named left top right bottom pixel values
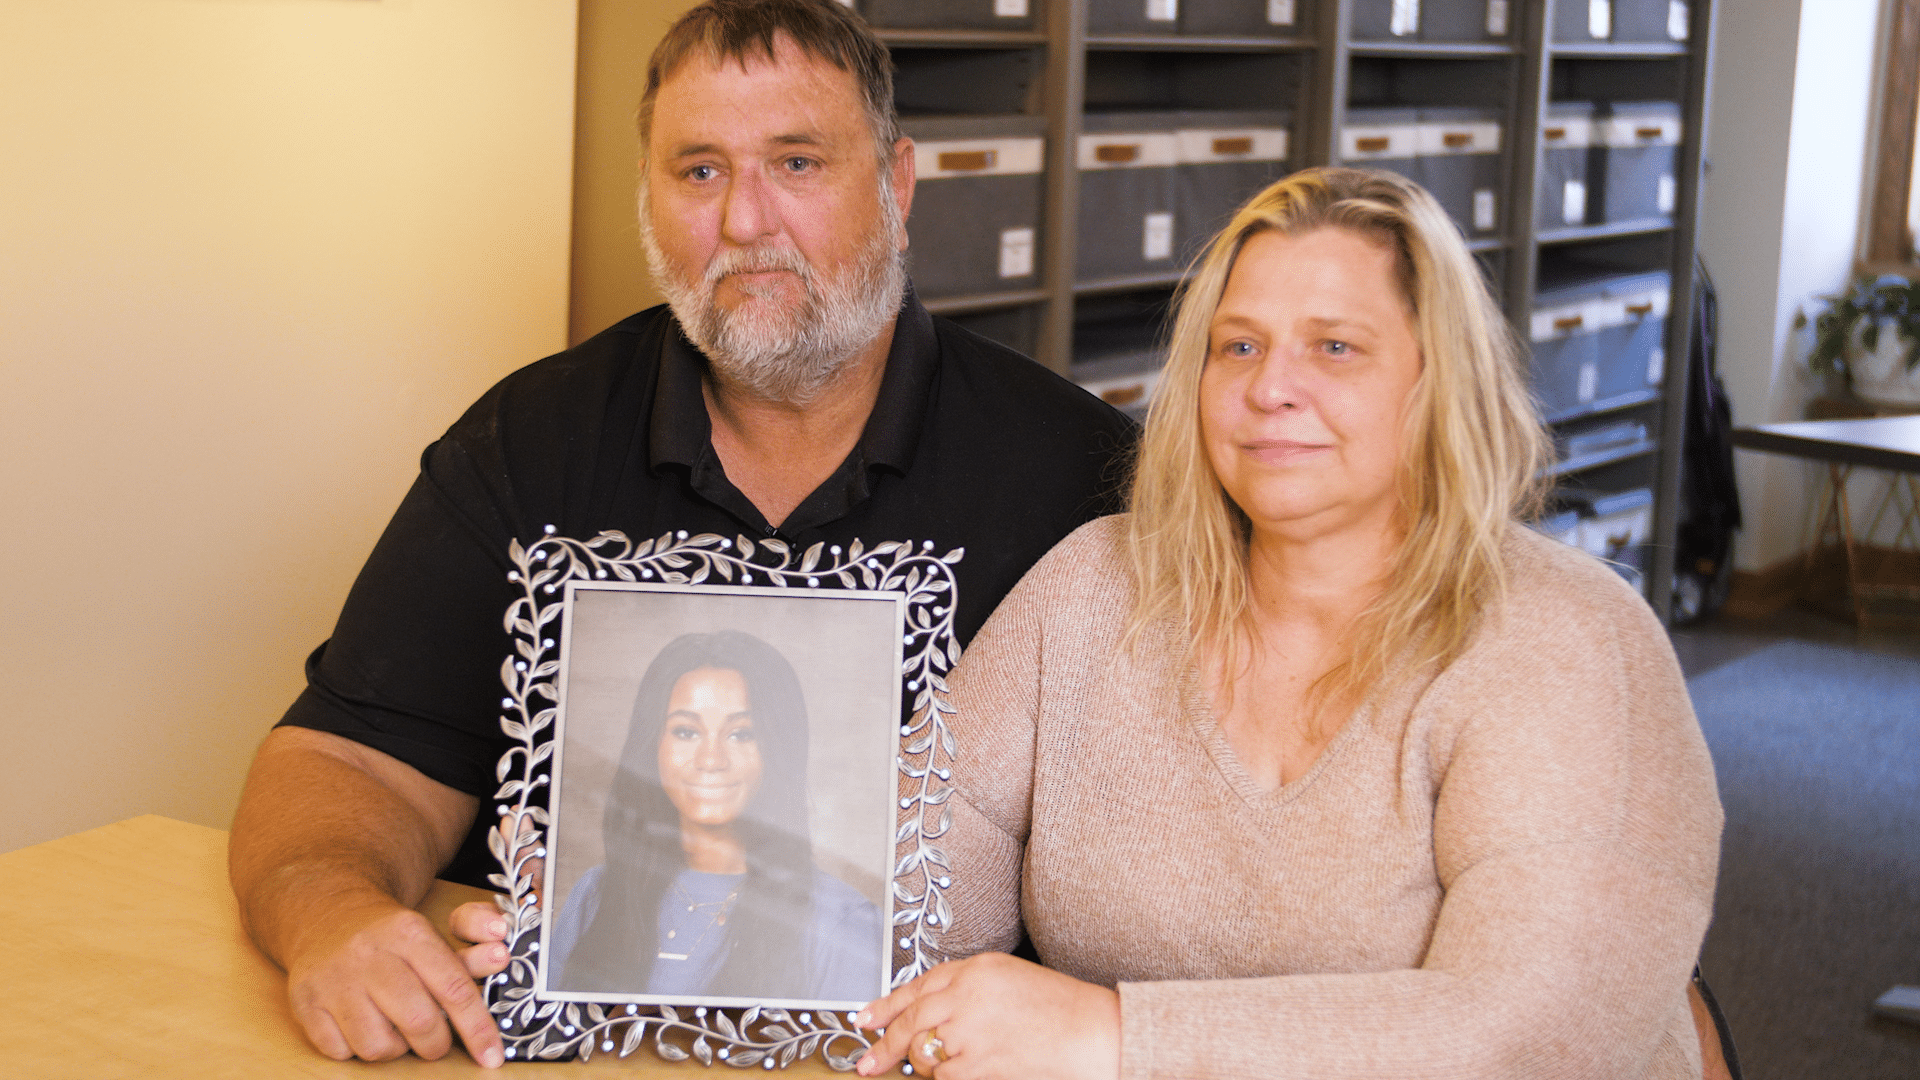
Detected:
left=547, top=630, right=883, bottom=1001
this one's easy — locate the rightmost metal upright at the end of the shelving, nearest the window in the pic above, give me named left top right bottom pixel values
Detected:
left=1647, top=0, right=1716, bottom=623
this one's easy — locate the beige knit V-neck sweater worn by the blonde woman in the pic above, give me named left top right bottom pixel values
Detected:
left=941, top=517, right=1720, bottom=1080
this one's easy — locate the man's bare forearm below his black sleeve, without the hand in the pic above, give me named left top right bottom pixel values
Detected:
left=228, top=728, right=478, bottom=967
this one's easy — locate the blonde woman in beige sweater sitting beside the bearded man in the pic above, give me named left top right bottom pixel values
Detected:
left=860, top=169, right=1720, bottom=1080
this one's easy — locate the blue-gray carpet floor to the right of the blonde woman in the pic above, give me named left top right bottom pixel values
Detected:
left=1674, top=634, right=1920, bottom=1080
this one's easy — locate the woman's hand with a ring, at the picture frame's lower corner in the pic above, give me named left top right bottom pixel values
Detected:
left=858, top=953, right=1119, bottom=1080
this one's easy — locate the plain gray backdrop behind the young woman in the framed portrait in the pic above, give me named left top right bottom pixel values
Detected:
left=547, top=586, right=902, bottom=926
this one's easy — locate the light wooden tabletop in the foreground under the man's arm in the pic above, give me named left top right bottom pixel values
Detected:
left=0, top=817, right=851, bottom=1080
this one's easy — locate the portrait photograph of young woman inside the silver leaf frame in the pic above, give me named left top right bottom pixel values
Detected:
left=538, top=582, right=906, bottom=1009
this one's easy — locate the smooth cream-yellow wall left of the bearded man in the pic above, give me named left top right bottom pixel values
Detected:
left=0, top=0, right=576, bottom=849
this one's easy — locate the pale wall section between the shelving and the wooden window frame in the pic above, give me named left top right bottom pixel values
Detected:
left=1699, top=0, right=1884, bottom=571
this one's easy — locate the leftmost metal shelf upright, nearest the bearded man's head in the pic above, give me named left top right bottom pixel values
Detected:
left=1035, top=0, right=1087, bottom=375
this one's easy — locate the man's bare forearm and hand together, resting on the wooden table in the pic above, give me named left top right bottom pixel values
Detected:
left=228, top=728, right=505, bottom=1067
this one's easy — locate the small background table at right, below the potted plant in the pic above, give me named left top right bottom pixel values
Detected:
left=1732, top=415, right=1920, bottom=628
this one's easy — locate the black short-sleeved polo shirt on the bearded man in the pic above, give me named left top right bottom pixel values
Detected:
left=280, top=296, right=1135, bottom=884
